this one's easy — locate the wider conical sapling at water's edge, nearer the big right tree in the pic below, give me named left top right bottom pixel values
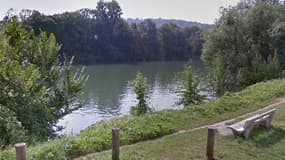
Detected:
left=176, top=64, right=205, bottom=106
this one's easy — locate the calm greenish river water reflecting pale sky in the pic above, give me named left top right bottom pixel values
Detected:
left=58, top=61, right=205, bottom=134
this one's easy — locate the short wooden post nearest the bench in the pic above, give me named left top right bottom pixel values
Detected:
left=206, top=128, right=216, bottom=160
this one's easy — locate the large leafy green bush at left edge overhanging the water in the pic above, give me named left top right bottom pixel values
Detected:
left=0, top=19, right=85, bottom=145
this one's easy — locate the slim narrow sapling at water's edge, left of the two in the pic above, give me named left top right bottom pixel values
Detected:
left=131, top=72, right=150, bottom=115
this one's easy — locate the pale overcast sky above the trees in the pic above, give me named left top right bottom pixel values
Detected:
left=0, top=0, right=240, bottom=23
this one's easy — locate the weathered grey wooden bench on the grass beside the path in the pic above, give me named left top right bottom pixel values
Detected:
left=228, top=109, right=276, bottom=138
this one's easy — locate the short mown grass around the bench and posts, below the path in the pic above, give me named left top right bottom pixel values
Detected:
left=77, top=105, right=285, bottom=160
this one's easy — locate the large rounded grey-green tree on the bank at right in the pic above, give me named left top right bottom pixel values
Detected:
left=202, top=1, right=285, bottom=95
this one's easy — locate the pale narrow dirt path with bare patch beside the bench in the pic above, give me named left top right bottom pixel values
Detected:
left=173, top=97, right=285, bottom=136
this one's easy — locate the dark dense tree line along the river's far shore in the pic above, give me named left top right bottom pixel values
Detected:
left=4, top=0, right=203, bottom=64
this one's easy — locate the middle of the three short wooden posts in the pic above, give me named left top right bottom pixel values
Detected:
left=112, top=128, right=120, bottom=160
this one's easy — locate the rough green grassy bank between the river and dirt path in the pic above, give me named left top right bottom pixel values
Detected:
left=0, top=80, right=285, bottom=160
